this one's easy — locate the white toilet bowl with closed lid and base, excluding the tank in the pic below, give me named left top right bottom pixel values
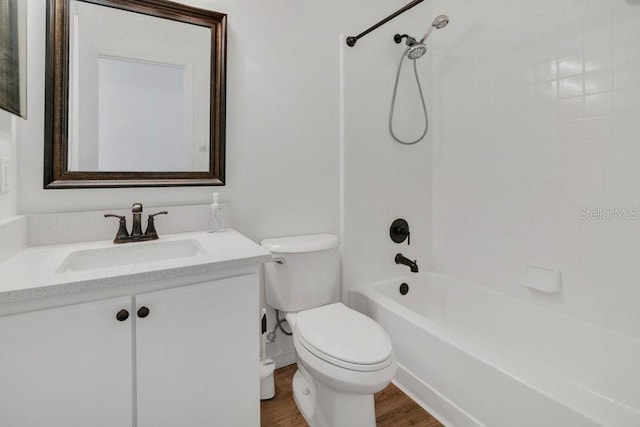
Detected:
left=286, top=303, right=396, bottom=427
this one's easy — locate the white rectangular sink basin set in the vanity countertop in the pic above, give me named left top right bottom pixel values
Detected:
left=56, top=239, right=206, bottom=273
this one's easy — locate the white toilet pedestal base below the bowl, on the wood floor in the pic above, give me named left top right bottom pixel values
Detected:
left=293, top=364, right=376, bottom=427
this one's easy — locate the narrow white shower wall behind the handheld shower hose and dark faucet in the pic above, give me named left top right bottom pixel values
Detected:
left=341, top=2, right=436, bottom=301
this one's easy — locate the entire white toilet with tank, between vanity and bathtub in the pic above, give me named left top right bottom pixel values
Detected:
left=262, top=234, right=396, bottom=427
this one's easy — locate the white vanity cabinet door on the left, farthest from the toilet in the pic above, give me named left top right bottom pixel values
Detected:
left=0, top=297, right=133, bottom=427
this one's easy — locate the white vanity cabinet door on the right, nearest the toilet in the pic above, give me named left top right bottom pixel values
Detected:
left=135, top=274, right=260, bottom=427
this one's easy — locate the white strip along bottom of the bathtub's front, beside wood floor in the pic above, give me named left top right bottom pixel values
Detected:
left=392, top=363, right=483, bottom=427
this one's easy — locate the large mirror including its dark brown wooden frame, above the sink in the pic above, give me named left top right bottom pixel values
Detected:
left=43, top=0, right=226, bottom=188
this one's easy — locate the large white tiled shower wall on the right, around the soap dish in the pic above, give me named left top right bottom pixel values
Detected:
left=433, top=0, right=640, bottom=342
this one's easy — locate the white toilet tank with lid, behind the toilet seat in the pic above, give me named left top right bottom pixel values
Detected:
left=262, top=234, right=339, bottom=312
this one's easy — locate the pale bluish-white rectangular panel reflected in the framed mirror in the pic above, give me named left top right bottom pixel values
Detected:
left=96, top=58, right=189, bottom=172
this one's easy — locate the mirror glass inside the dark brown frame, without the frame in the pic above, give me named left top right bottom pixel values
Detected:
left=68, top=0, right=211, bottom=172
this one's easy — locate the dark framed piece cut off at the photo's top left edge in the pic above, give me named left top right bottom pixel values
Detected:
left=0, top=0, right=27, bottom=118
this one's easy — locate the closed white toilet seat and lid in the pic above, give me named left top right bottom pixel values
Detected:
left=295, top=303, right=394, bottom=372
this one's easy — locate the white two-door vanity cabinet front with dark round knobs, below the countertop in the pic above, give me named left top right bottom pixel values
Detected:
left=0, top=274, right=259, bottom=427
